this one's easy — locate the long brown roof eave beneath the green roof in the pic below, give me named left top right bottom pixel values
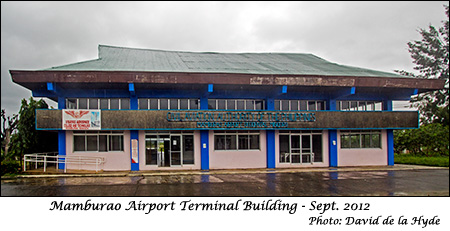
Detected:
left=10, top=70, right=445, bottom=93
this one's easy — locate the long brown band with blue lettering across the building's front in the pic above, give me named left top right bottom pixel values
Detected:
left=36, top=109, right=419, bottom=130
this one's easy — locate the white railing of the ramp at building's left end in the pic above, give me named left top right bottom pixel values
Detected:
left=23, top=153, right=106, bottom=172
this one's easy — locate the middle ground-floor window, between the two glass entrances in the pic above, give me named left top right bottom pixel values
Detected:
left=214, top=131, right=260, bottom=151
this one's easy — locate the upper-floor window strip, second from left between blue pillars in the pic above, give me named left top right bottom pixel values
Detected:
left=138, top=98, right=200, bottom=110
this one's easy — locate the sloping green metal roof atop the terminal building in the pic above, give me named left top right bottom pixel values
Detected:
left=45, top=45, right=401, bottom=77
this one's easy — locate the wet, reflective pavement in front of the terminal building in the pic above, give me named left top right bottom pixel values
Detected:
left=1, top=165, right=449, bottom=196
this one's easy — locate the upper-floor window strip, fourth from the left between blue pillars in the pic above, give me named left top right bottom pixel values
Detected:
left=275, top=100, right=326, bottom=111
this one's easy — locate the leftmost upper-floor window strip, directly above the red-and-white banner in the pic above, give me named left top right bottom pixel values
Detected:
left=66, top=98, right=130, bottom=109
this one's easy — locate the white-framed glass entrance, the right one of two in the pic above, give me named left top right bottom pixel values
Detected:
left=279, top=131, right=323, bottom=164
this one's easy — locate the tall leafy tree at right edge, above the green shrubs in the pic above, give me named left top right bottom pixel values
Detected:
left=397, top=6, right=449, bottom=126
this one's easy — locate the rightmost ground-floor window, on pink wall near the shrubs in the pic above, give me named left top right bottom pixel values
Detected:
left=341, top=130, right=381, bottom=149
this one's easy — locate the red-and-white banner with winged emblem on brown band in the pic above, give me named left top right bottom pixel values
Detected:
left=62, top=109, right=101, bottom=130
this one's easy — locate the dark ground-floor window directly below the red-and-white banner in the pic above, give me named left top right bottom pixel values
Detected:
left=73, top=131, right=124, bottom=152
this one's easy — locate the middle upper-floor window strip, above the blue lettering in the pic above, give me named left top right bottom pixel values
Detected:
left=208, top=99, right=265, bottom=110
